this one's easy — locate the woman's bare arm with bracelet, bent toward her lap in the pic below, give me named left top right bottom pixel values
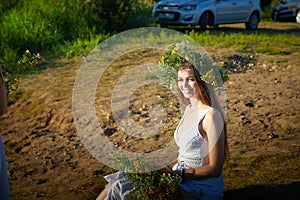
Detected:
left=184, top=109, right=225, bottom=179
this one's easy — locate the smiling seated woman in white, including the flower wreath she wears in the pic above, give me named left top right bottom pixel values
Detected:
left=97, top=43, right=228, bottom=200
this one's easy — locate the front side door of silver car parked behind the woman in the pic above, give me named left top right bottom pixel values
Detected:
left=215, top=0, right=238, bottom=24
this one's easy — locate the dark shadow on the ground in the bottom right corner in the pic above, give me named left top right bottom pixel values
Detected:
left=223, top=182, right=300, bottom=200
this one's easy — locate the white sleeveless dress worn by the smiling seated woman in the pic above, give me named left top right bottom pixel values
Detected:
left=173, top=108, right=224, bottom=200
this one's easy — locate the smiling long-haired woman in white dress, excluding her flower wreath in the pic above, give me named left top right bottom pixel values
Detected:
left=172, top=62, right=228, bottom=200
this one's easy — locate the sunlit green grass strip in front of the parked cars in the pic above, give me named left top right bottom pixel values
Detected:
left=186, top=28, right=300, bottom=55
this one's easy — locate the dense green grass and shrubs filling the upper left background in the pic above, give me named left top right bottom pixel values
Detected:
left=0, top=0, right=152, bottom=83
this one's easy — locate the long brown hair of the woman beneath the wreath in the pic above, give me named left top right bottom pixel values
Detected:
left=176, top=62, right=229, bottom=160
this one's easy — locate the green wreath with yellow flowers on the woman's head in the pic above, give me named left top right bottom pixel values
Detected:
left=149, top=41, right=228, bottom=93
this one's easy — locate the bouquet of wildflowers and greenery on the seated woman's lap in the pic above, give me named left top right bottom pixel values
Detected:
left=112, top=156, right=181, bottom=200
